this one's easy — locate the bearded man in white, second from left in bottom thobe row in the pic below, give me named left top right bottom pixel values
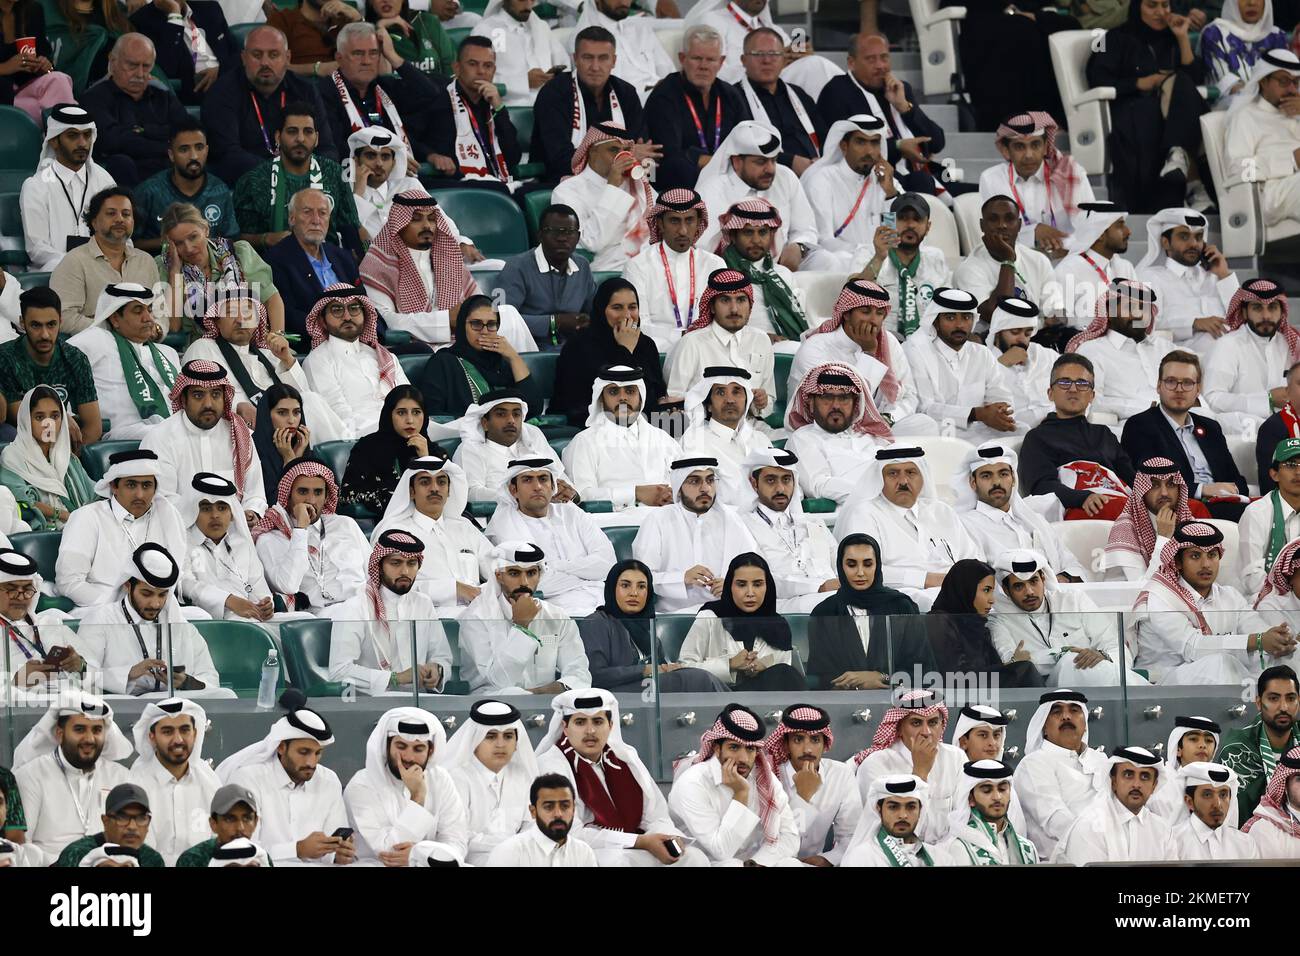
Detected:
left=127, top=697, right=221, bottom=866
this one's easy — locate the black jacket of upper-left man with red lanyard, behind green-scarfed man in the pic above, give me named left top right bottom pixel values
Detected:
left=203, top=65, right=346, bottom=185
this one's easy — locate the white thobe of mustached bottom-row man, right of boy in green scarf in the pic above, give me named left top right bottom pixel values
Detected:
left=1013, top=740, right=1110, bottom=860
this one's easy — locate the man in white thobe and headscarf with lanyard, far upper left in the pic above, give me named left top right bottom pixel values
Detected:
left=18, top=103, right=114, bottom=272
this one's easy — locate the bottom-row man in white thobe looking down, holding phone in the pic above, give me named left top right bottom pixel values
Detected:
left=217, top=696, right=356, bottom=866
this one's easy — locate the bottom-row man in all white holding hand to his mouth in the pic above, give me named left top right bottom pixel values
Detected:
left=343, top=708, right=469, bottom=866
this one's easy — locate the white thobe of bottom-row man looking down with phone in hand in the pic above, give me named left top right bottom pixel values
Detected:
left=229, top=754, right=348, bottom=866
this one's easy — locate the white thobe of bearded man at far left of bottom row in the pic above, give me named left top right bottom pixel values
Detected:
left=13, top=747, right=129, bottom=866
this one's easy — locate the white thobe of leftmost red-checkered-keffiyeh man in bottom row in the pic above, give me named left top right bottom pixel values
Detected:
left=668, top=756, right=801, bottom=866
